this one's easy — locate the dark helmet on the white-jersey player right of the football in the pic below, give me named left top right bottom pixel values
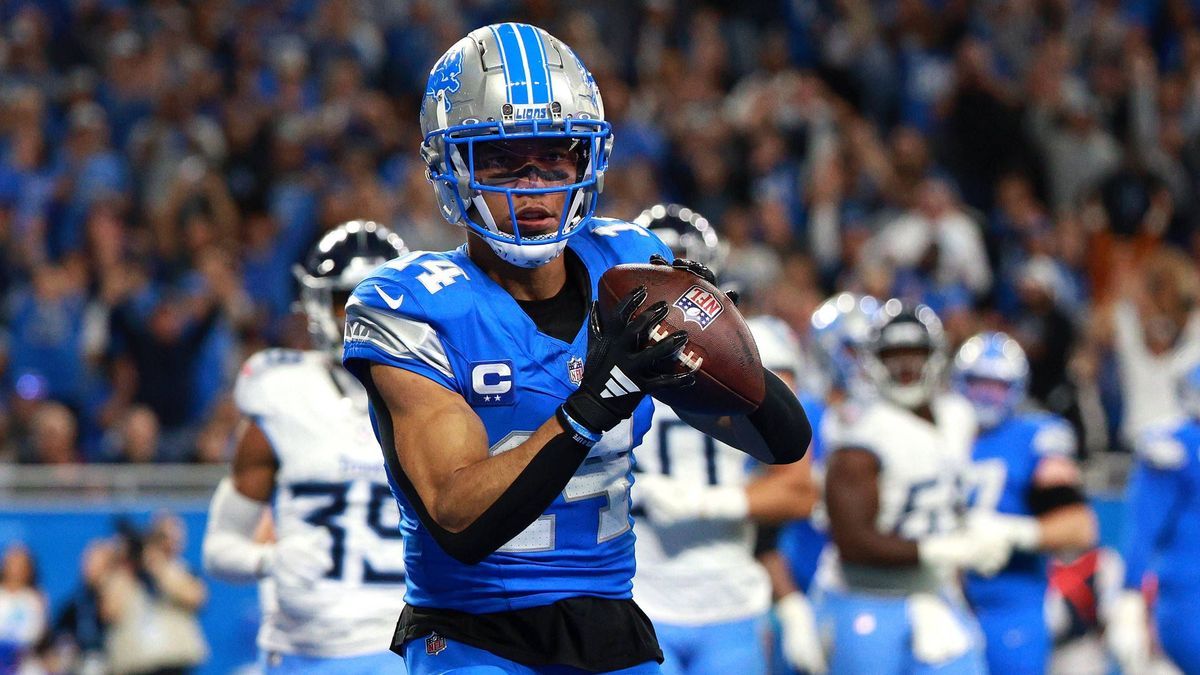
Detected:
left=859, top=298, right=947, bottom=410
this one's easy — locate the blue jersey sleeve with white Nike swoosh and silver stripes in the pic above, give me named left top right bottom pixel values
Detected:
left=342, top=258, right=458, bottom=392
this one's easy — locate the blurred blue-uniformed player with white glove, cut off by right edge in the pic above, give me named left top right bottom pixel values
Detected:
left=1105, top=365, right=1200, bottom=674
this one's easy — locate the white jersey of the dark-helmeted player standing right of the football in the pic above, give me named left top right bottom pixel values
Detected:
left=818, top=394, right=977, bottom=593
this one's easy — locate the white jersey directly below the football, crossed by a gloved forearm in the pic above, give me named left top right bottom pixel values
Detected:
left=634, top=401, right=770, bottom=626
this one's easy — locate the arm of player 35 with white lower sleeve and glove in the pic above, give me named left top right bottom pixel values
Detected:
left=203, top=419, right=278, bottom=581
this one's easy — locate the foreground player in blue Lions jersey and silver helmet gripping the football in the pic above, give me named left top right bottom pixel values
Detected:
left=344, top=23, right=810, bottom=674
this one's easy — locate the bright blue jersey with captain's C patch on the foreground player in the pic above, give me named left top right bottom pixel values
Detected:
left=343, top=219, right=671, bottom=613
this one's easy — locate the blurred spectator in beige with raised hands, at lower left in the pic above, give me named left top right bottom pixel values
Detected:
left=100, top=514, right=209, bottom=675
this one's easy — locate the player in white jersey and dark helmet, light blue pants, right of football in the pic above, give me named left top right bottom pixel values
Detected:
left=817, top=299, right=1012, bottom=674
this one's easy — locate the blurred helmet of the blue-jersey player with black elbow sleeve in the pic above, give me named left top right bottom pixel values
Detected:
left=950, top=333, right=1030, bottom=429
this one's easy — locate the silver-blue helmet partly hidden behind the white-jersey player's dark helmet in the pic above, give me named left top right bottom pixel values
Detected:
left=810, top=293, right=880, bottom=392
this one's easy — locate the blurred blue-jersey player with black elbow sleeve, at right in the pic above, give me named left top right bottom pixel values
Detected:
left=952, top=333, right=1098, bottom=673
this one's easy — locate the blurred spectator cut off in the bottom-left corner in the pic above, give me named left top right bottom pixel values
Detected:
left=0, top=543, right=48, bottom=673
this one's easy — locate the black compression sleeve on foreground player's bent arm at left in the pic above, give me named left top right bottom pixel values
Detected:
left=364, top=377, right=589, bottom=565
